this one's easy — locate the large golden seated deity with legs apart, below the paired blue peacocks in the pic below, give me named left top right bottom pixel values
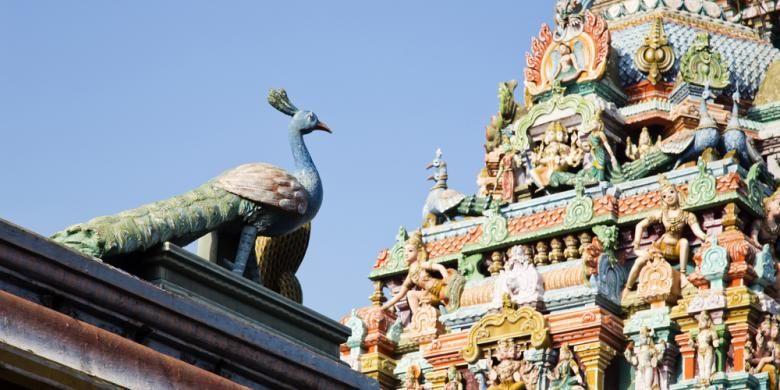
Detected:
left=626, top=175, right=709, bottom=289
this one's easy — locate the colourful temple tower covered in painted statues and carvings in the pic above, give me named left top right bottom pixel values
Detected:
left=341, top=0, right=780, bottom=390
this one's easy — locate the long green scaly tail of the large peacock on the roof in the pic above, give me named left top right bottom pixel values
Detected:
left=52, top=182, right=256, bottom=258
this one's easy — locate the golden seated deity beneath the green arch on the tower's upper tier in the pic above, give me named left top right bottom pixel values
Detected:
left=530, top=122, right=584, bottom=190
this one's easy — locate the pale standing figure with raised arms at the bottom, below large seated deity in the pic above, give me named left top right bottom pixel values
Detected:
left=625, top=326, right=666, bottom=390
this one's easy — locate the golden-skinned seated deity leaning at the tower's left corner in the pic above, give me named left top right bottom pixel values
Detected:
left=382, top=230, right=460, bottom=323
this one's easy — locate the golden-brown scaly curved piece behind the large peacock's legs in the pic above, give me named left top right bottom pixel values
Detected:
left=255, top=222, right=311, bottom=303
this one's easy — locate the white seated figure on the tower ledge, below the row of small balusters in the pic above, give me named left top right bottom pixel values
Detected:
left=491, top=245, right=544, bottom=308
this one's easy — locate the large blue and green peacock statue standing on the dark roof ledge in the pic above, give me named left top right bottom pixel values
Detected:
left=52, top=90, right=331, bottom=280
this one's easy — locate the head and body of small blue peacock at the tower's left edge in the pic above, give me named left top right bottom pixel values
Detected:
left=423, top=149, right=466, bottom=227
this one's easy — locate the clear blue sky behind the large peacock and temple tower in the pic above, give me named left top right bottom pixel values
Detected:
left=0, top=0, right=553, bottom=319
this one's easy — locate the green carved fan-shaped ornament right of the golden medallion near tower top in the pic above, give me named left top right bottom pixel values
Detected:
left=680, top=32, right=731, bottom=89
